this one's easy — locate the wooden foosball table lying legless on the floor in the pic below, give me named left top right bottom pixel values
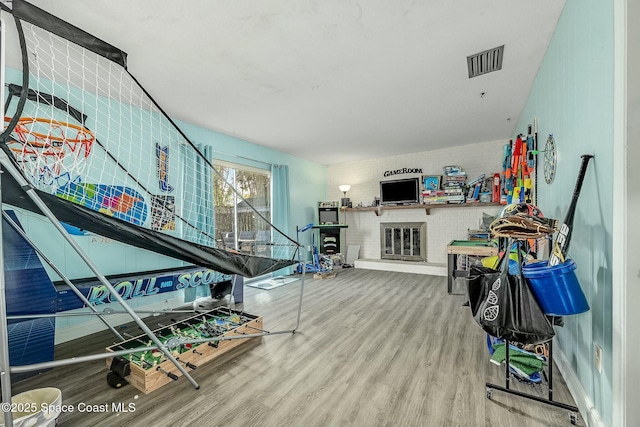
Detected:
left=107, top=307, right=264, bottom=394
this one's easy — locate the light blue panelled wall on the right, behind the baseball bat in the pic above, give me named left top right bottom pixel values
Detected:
left=517, top=0, right=614, bottom=425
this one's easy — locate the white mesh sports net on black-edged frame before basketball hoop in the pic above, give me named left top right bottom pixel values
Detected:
left=4, top=2, right=297, bottom=272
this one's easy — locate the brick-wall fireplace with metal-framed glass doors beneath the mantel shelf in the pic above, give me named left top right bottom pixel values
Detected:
left=380, top=222, right=427, bottom=261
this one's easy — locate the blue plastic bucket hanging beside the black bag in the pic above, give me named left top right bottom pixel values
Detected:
left=522, top=259, right=589, bottom=316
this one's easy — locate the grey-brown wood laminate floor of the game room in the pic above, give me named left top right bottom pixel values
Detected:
left=12, top=269, right=583, bottom=427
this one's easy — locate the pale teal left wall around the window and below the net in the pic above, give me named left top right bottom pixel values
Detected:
left=6, top=69, right=326, bottom=280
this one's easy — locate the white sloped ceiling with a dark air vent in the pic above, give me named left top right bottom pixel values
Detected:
left=22, top=0, right=564, bottom=164
